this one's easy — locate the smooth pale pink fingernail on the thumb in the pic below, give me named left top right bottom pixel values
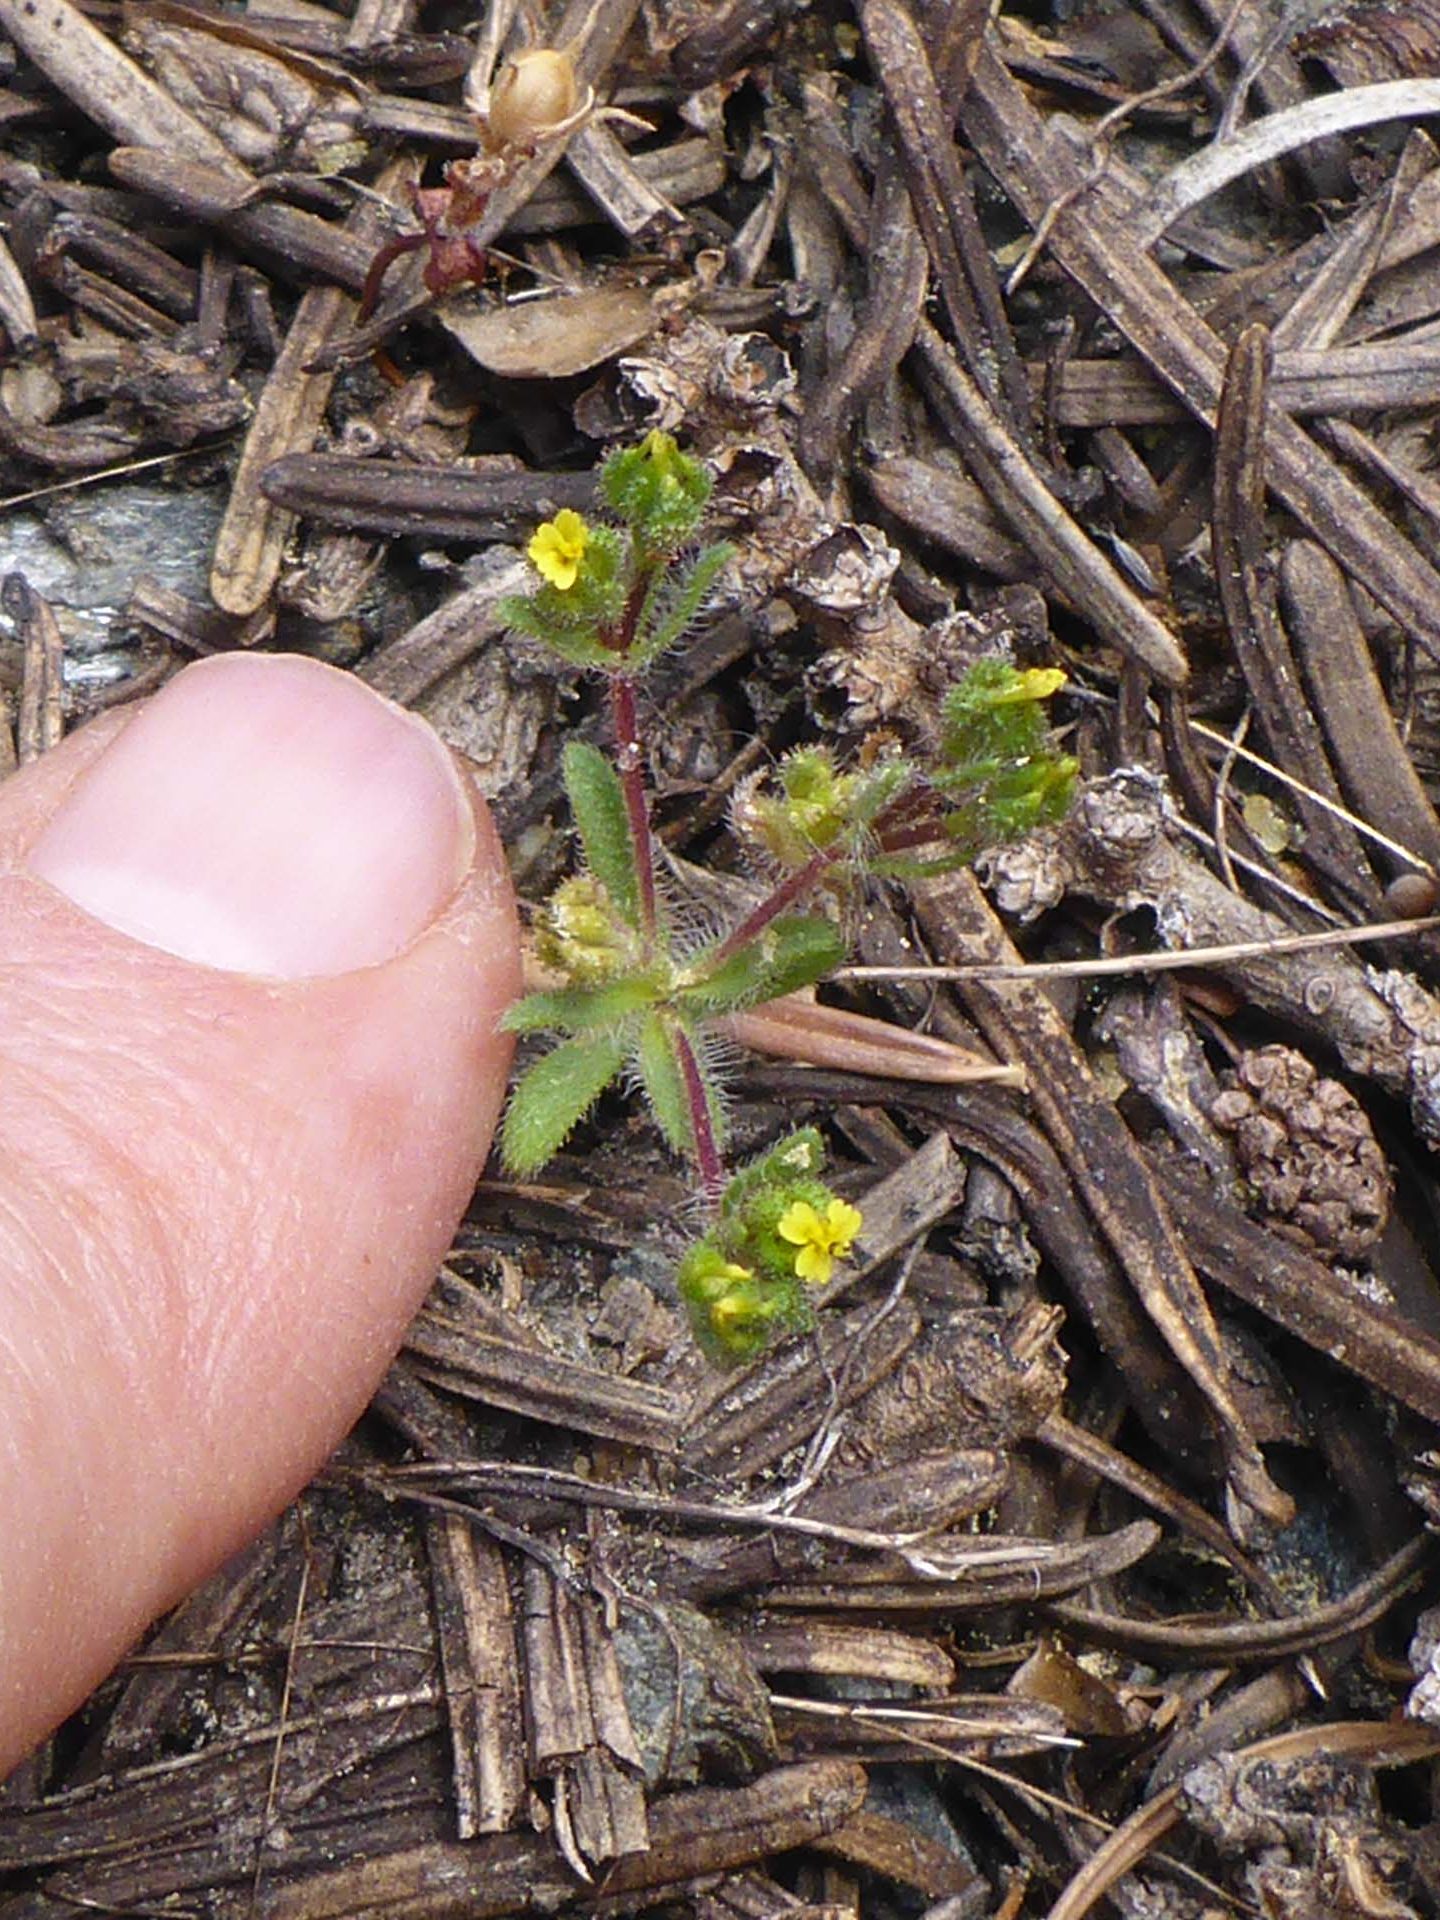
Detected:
left=29, top=653, right=474, bottom=979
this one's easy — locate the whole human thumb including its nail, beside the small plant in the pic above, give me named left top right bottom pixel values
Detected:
left=0, top=655, right=518, bottom=1778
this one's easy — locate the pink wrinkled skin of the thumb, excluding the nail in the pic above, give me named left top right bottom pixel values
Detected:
left=0, top=695, right=518, bottom=1778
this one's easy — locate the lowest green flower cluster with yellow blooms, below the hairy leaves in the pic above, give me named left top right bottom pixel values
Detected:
left=678, top=1127, right=864, bottom=1361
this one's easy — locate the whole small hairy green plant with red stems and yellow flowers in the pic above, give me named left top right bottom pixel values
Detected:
left=501, top=432, right=1075, bottom=1359
